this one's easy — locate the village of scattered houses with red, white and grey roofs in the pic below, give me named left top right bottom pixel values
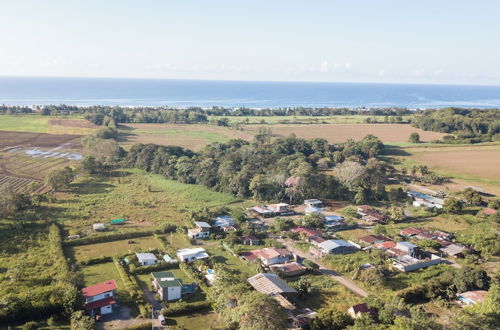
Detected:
left=80, top=190, right=496, bottom=329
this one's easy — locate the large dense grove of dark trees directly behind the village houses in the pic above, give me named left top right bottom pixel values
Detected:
left=123, top=132, right=391, bottom=202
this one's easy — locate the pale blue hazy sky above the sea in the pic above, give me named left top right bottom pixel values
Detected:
left=0, top=0, right=500, bottom=85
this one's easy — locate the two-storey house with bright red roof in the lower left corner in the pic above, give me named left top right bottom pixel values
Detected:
left=82, top=280, right=117, bottom=316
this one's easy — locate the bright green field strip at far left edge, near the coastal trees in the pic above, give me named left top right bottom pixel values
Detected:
left=0, top=115, right=97, bottom=135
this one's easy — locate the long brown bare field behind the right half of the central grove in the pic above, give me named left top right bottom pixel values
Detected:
left=244, top=124, right=445, bottom=143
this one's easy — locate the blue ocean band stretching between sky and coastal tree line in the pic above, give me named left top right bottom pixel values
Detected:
left=0, top=77, right=500, bottom=109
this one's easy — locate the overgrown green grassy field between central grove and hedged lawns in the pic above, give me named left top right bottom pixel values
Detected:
left=47, top=170, right=239, bottom=236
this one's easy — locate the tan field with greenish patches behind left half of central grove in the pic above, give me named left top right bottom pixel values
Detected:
left=120, top=124, right=252, bottom=150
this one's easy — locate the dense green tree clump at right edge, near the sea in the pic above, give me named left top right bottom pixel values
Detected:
left=411, top=108, right=500, bottom=143
